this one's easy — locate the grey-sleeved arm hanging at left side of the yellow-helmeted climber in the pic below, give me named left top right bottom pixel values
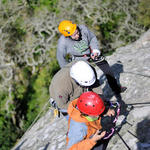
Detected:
left=56, top=36, right=68, bottom=68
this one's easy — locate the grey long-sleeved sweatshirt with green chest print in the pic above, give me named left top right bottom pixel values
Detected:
left=57, top=25, right=99, bottom=68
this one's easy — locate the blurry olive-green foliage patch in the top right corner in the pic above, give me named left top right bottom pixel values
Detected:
left=137, top=0, right=150, bottom=28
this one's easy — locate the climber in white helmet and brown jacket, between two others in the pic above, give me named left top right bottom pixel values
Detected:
left=49, top=61, right=102, bottom=116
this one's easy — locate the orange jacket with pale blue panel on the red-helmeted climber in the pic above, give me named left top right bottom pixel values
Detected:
left=67, top=99, right=102, bottom=150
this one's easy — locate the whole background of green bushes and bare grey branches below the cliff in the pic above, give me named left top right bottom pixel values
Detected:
left=0, top=0, right=150, bottom=150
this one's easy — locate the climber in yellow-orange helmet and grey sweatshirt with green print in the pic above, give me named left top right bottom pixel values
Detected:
left=57, top=20, right=127, bottom=96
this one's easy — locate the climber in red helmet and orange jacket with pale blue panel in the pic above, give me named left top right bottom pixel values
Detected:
left=67, top=91, right=115, bottom=150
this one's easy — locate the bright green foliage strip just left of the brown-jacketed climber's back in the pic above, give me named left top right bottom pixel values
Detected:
left=24, top=59, right=59, bottom=130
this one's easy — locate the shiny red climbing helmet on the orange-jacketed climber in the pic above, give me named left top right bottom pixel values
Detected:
left=77, top=92, right=105, bottom=116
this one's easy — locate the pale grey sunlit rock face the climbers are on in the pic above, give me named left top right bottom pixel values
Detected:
left=12, top=30, right=150, bottom=150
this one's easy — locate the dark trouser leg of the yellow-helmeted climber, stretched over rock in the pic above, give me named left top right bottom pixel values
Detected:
left=95, top=60, right=121, bottom=94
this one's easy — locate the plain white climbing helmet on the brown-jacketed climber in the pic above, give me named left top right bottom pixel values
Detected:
left=70, top=61, right=96, bottom=86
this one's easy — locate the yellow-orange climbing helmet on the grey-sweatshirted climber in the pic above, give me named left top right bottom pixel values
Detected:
left=58, top=20, right=77, bottom=36
